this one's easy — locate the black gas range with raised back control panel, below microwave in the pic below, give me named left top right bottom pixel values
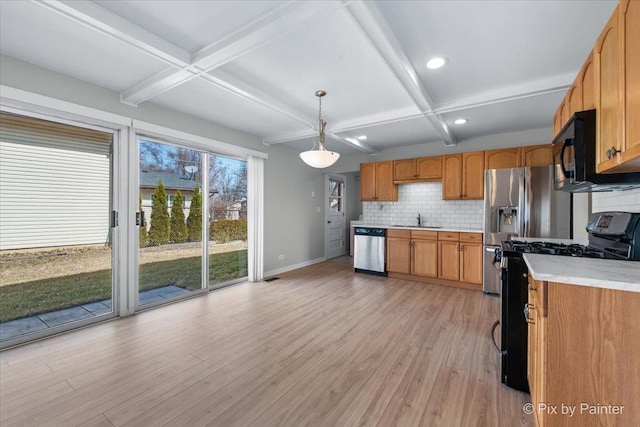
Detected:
left=491, top=212, right=640, bottom=392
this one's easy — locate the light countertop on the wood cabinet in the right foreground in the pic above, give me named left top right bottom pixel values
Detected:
left=524, top=254, right=640, bottom=292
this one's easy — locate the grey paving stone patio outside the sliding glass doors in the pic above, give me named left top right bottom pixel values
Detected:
left=0, top=286, right=191, bottom=341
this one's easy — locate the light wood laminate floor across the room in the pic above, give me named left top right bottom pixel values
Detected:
left=0, top=261, right=533, bottom=427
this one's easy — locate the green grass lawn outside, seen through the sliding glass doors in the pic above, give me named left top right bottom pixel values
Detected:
left=0, top=250, right=247, bottom=322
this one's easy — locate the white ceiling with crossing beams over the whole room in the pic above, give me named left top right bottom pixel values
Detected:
left=0, top=0, right=617, bottom=154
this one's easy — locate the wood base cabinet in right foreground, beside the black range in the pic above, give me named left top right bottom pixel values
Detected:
left=527, top=277, right=640, bottom=427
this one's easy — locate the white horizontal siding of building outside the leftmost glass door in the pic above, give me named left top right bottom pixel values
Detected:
left=0, top=115, right=112, bottom=250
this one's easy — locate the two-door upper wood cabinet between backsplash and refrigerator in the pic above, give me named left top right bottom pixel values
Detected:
left=442, top=151, right=484, bottom=200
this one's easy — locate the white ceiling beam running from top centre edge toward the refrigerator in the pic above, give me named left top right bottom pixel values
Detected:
left=344, top=0, right=456, bottom=145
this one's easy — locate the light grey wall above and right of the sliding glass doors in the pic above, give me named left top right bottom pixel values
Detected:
left=0, top=56, right=325, bottom=271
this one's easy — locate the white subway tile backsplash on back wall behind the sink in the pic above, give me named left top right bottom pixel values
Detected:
left=362, top=182, right=483, bottom=230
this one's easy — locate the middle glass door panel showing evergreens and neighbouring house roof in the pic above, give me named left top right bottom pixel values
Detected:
left=137, top=139, right=206, bottom=307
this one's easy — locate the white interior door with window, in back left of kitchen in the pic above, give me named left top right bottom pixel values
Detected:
left=325, top=175, right=347, bottom=259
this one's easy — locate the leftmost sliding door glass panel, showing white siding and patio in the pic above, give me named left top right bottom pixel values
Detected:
left=0, top=113, right=116, bottom=347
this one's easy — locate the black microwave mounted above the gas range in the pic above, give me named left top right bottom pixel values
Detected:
left=553, top=110, right=640, bottom=193
